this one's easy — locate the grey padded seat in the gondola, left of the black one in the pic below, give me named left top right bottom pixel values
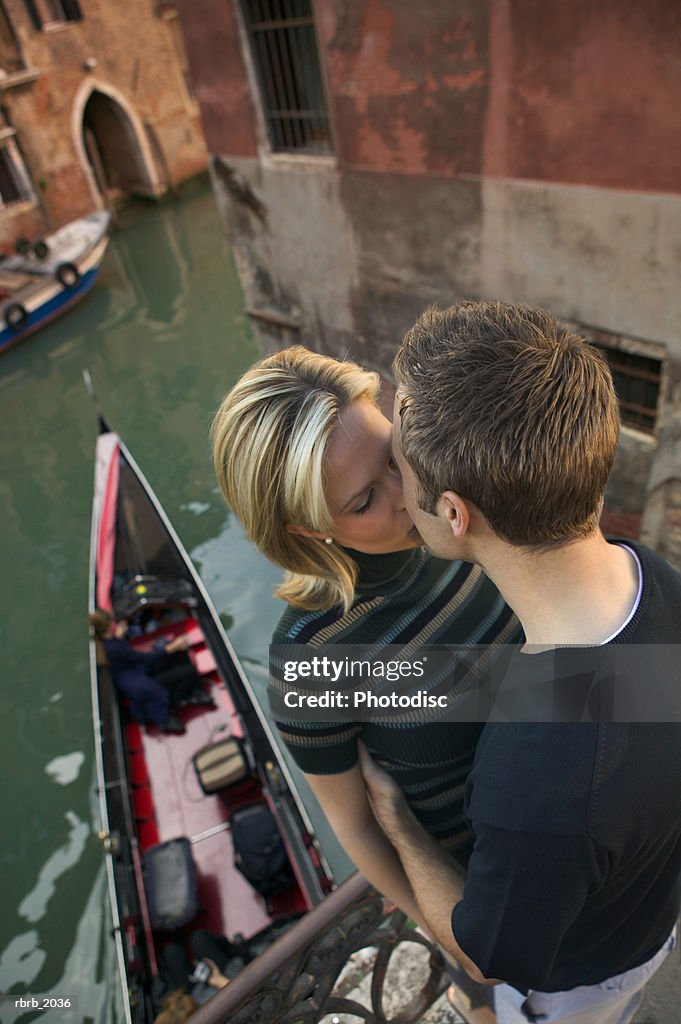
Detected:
left=144, top=836, right=200, bottom=931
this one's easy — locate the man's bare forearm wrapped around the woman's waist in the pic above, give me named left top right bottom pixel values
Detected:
left=359, top=742, right=500, bottom=985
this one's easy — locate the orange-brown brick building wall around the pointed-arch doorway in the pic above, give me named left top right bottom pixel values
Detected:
left=0, top=0, right=208, bottom=244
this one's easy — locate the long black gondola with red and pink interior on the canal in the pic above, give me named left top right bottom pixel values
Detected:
left=89, top=401, right=333, bottom=1024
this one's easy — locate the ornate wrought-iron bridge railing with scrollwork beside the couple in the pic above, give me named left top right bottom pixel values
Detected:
left=191, top=874, right=449, bottom=1024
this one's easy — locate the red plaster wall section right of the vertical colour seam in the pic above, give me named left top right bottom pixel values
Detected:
left=484, top=0, right=681, bottom=194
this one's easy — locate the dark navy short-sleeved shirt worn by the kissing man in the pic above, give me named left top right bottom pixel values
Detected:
left=452, top=541, right=681, bottom=992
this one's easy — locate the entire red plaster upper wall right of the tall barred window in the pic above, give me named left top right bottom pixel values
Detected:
left=315, top=0, right=681, bottom=194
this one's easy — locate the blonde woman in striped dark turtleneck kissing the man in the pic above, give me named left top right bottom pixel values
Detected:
left=212, top=346, right=520, bottom=923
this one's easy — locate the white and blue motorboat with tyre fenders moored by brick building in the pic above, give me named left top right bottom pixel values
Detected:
left=0, top=210, right=111, bottom=353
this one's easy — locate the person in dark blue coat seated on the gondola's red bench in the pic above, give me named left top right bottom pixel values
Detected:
left=88, top=608, right=213, bottom=733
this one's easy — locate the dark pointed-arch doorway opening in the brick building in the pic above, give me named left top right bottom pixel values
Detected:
left=82, top=88, right=159, bottom=205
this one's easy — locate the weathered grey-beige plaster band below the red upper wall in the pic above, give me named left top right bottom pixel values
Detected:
left=209, top=156, right=681, bottom=358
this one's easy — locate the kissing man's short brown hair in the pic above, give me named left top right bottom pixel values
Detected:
left=394, top=301, right=620, bottom=546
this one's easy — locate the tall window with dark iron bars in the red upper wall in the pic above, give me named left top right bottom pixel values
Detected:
left=242, top=0, right=332, bottom=154
